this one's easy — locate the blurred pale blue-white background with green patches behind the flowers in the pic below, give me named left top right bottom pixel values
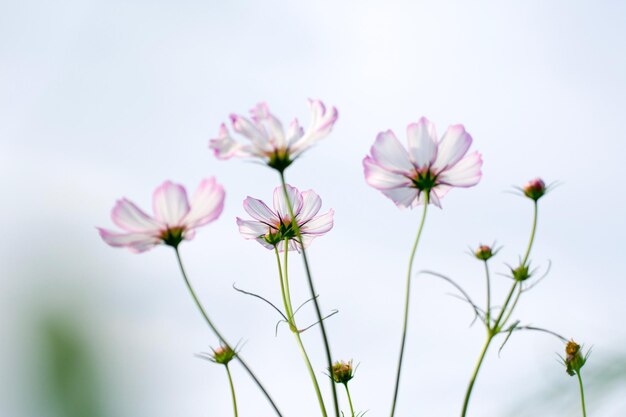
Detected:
left=0, top=0, right=626, bottom=417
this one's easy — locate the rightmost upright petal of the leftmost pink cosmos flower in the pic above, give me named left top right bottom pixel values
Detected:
left=184, top=178, right=224, bottom=228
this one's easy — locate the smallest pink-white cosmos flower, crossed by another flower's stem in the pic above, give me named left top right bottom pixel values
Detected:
left=237, top=185, right=334, bottom=252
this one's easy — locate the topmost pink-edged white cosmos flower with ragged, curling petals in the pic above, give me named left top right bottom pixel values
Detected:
left=209, top=100, right=337, bottom=172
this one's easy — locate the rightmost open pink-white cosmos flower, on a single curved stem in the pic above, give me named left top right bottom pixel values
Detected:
left=363, top=117, right=483, bottom=208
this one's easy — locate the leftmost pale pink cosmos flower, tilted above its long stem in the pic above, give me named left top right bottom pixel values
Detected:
left=98, top=178, right=224, bottom=253
